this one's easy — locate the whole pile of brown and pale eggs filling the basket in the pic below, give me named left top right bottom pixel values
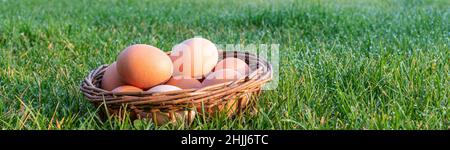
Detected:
left=101, top=38, right=249, bottom=93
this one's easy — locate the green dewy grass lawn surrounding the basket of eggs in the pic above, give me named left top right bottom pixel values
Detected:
left=0, top=0, right=450, bottom=129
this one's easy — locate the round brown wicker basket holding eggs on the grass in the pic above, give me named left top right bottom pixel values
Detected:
left=80, top=51, right=272, bottom=124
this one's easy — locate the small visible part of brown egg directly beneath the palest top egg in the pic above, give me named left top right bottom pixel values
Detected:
left=166, top=75, right=202, bottom=89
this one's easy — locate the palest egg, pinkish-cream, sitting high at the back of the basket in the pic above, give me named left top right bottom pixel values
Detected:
left=170, top=38, right=219, bottom=79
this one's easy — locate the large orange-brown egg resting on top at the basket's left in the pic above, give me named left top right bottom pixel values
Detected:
left=117, top=44, right=173, bottom=89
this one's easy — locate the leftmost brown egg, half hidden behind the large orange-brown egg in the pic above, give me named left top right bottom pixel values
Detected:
left=102, top=62, right=125, bottom=91
